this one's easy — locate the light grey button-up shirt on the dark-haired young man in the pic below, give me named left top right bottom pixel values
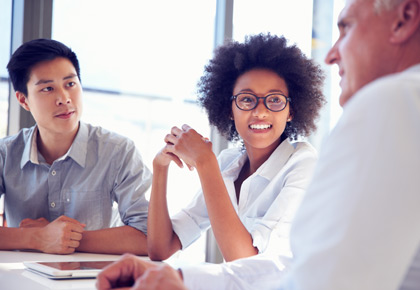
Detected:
left=0, top=122, right=151, bottom=233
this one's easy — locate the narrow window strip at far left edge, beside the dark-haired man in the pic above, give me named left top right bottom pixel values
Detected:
left=0, top=0, right=12, bottom=138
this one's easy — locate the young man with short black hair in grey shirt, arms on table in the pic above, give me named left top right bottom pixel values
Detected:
left=0, top=39, right=151, bottom=255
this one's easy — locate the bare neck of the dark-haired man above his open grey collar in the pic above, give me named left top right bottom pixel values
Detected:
left=37, top=123, right=79, bottom=164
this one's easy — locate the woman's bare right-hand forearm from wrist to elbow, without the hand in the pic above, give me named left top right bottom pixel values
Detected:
left=197, top=158, right=258, bottom=261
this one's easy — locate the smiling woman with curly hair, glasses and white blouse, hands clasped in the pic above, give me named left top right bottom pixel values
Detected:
left=148, top=34, right=325, bottom=261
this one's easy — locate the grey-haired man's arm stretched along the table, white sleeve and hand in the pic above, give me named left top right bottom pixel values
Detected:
left=96, top=255, right=289, bottom=290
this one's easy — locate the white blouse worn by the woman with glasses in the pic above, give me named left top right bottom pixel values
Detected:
left=172, top=140, right=317, bottom=254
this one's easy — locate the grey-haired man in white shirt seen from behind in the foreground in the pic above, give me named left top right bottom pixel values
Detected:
left=97, top=0, right=420, bottom=290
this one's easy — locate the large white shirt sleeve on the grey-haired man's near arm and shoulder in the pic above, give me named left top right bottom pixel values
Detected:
left=284, top=75, right=420, bottom=290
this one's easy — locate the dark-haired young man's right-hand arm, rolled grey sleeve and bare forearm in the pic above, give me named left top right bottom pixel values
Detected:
left=105, top=140, right=152, bottom=255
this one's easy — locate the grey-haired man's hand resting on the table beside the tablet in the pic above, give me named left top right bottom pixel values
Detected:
left=96, top=254, right=186, bottom=290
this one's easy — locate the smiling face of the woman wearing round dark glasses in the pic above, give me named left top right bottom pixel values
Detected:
left=232, top=69, right=291, bottom=154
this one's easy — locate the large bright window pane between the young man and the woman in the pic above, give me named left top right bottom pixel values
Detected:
left=52, top=0, right=216, bottom=261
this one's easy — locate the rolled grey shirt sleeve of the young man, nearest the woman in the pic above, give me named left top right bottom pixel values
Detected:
left=113, top=140, right=152, bottom=234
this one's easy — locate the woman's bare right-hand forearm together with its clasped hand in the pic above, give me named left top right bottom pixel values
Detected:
left=168, top=125, right=258, bottom=261
